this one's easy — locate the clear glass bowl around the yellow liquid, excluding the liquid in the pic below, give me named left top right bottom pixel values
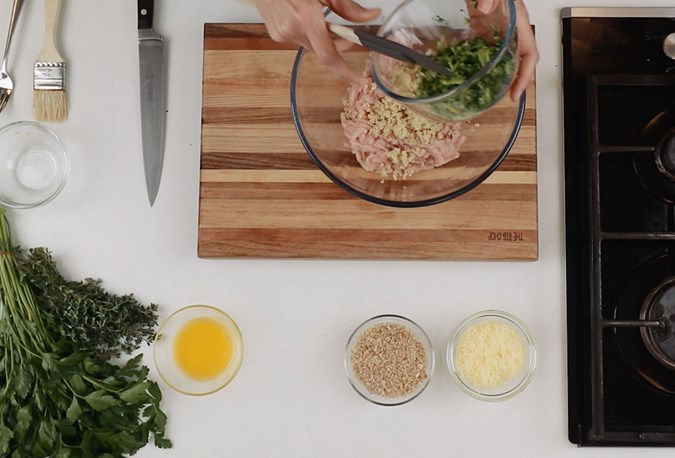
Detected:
left=153, top=305, right=244, bottom=396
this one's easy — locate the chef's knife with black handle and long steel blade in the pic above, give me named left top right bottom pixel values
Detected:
left=138, top=0, right=166, bottom=206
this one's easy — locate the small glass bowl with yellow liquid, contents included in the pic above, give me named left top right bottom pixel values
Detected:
left=153, top=305, right=244, bottom=396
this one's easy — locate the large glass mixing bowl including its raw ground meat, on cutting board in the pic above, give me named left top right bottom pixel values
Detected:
left=290, top=8, right=525, bottom=207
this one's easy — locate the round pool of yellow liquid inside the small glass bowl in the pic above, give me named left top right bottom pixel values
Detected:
left=173, top=317, right=234, bottom=381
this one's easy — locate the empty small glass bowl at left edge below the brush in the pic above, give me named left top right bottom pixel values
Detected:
left=0, top=121, right=70, bottom=208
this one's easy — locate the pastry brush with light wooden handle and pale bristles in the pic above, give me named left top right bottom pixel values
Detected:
left=33, top=0, right=68, bottom=121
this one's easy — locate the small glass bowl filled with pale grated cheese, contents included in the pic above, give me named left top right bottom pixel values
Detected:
left=446, top=310, right=537, bottom=401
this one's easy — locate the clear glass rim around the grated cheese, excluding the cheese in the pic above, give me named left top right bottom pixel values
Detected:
left=446, top=310, right=537, bottom=401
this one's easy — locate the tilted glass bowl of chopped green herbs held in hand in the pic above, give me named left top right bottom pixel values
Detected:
left=371, top=0, right=518, bottom=121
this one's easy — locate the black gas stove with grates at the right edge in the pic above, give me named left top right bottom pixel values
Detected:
left=561, top=8, right=675, bottom=446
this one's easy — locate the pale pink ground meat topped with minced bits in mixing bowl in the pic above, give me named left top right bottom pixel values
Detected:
left=341, top=63, right=464, bottom=179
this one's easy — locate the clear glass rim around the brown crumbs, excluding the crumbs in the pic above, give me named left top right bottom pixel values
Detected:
left=344, top=315, right=435, bottom=406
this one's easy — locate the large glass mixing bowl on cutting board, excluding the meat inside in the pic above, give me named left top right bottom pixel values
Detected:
left=291, top=44, right=525, bottom=207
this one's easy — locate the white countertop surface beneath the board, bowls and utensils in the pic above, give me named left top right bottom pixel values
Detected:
left=0, top=0, right=673, bottom=458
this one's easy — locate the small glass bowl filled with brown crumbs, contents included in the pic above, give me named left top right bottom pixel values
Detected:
left=344, top=315, right=435, bottom=406
